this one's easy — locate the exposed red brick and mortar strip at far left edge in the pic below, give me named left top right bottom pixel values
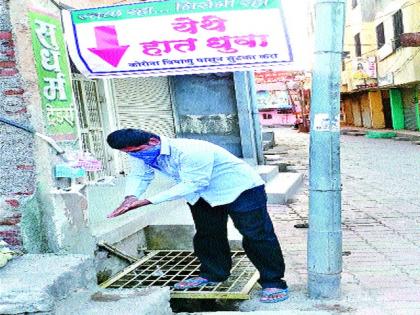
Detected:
left=0, top=0, right=35, bottom=249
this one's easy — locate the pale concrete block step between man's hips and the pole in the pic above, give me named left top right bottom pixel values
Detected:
left=265, top=173, right=303, bottom=204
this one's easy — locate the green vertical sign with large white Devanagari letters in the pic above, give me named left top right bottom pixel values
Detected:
left=29, top=11, right=77, bottom=141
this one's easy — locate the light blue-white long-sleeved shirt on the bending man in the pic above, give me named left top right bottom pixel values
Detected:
left=125, top=136, right=264, bottom=207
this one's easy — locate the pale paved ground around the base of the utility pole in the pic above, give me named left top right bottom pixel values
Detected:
left=240, top=128, right=420, bottom=315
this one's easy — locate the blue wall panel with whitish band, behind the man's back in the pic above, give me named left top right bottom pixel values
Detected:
left=171, top=73, right=242, bottom=156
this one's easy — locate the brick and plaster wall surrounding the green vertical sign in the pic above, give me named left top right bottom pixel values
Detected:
left=0, top=0, right=94, bottom=254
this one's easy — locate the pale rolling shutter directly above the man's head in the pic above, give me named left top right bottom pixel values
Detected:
left=113, top=77, right=175, bottom=137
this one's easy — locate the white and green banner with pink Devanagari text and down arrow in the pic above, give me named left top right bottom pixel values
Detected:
left=63, top=0, right=293, bottom=77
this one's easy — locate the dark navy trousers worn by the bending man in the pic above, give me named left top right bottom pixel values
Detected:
left=190, top=186, right=287, bottom=289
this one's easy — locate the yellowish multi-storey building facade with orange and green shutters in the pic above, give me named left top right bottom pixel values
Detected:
left=341, top=0, right=420, bottom=131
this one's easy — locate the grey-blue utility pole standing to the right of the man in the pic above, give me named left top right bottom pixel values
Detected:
left=308, top=0, right=345, bottom=298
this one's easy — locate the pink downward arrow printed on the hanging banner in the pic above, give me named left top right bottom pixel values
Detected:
left=88, top=25, right=130, bottom=67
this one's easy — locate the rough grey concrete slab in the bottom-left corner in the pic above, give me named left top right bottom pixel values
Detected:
left=0, top=254, right=96, bottom=314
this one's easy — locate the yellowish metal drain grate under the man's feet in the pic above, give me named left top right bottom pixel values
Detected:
left=100, top=250, right=258, bottom=300
